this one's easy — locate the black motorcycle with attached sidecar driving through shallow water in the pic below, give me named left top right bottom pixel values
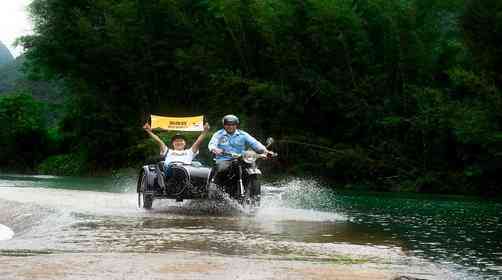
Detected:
left=137, top=138, right=277, bottom=209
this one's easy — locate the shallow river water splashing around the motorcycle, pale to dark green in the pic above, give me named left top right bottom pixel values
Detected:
left=0, top=174, right=502, bottom=279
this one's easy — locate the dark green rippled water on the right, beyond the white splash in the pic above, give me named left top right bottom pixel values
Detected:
left=340, top=191, right=502, bottom=275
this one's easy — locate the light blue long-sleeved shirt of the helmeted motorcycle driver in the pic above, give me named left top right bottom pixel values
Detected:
left=208, top=129, right=266, bottom=161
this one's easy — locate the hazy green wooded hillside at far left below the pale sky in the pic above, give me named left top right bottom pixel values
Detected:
left=0, top=56, right=64, bottom=171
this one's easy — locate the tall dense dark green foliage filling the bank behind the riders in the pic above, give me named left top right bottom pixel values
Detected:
left=1, top=0, right=502, bottom=193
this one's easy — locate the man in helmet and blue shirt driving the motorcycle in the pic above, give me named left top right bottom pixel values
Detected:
left=208, top=115, right=273, bottom=184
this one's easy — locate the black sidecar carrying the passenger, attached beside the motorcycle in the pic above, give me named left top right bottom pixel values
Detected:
left=137, top=161, right=211, bottom=209
